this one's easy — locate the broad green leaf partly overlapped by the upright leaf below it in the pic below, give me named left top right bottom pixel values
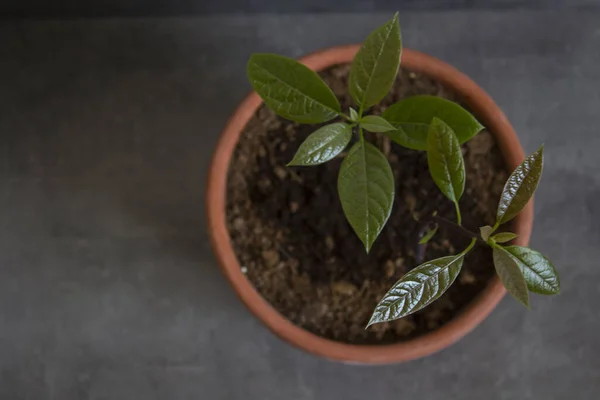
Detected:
left=381, top=96, right=483, bottom=150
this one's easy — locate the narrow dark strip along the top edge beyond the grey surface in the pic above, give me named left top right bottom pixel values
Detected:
left=0, top=0, right=600, bottom=18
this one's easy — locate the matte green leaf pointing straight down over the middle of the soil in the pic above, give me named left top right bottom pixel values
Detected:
left=338, top=141, right=394, bottom=253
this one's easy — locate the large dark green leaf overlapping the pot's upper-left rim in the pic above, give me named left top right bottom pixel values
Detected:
left=246, top=54, right=341, bottom=124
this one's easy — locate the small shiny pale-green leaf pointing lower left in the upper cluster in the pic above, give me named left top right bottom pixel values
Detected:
left=288, top=122, right=352, bottom=166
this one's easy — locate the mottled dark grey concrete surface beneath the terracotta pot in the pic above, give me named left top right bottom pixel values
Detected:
left=0, top=11, right=600, bottom=400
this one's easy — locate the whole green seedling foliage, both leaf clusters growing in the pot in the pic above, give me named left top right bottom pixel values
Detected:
left=247, top=13, right=560, bottom=325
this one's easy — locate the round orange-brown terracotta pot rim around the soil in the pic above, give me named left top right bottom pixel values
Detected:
left=206, top=45, right=533, bottom=364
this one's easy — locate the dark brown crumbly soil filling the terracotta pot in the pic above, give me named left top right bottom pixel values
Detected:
left=227, top=65, right=507, bottom=343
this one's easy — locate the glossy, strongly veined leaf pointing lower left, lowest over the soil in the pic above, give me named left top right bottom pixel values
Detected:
left=367, top=253, right=464, bottom=326
